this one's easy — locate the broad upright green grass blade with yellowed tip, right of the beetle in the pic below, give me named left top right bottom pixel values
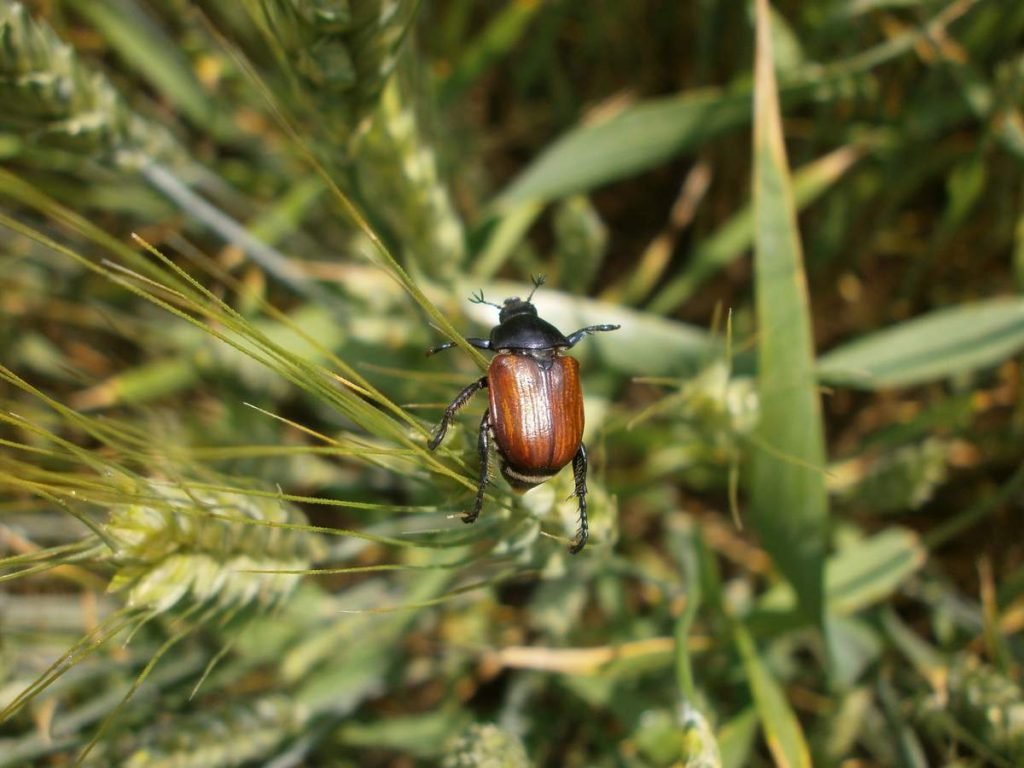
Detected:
left=750, top=0, right=828, bottom=627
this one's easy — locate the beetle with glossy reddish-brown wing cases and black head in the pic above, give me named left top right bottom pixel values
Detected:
left=427, top=276, right=620, bottom=555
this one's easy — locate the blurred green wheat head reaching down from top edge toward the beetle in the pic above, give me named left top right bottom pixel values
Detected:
left=257, top=0, right=466, bottom=281
